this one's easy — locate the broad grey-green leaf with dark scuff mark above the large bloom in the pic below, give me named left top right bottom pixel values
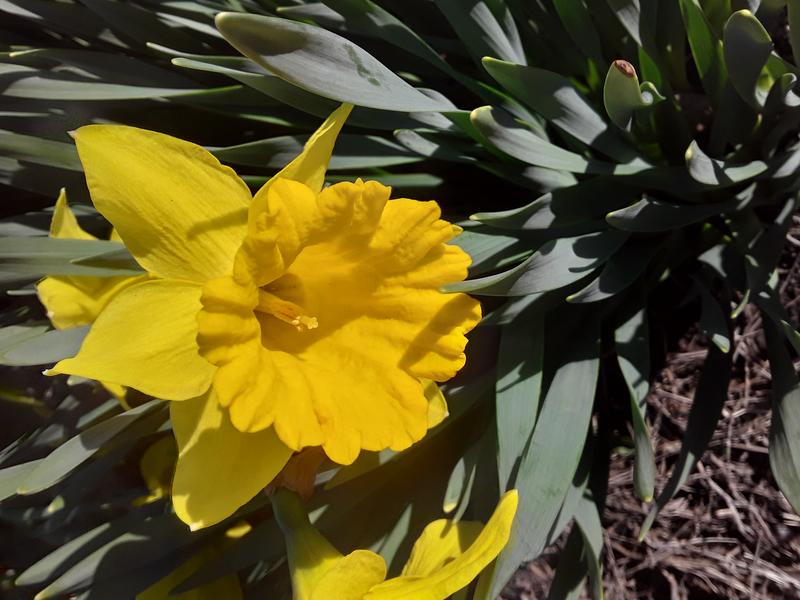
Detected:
left=216, top=13, right=455, bottom=112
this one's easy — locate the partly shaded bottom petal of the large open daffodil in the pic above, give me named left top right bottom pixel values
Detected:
left=170, top=392, right=292, bottom=529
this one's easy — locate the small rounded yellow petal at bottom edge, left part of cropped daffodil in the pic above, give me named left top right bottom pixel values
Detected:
left=311, top=550, right=386, bottom=600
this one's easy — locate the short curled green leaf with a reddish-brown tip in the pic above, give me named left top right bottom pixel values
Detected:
left=603, top=60, right=664, bottom=131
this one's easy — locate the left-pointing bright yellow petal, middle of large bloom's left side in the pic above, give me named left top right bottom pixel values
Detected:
left=47, top=280, right=214, bottom=400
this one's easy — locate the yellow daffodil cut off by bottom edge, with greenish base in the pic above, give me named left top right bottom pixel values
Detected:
left=272, top=490, right=517, bottom=600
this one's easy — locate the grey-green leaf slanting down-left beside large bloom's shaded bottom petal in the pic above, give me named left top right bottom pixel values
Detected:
left=17, top=400, right=159, bottom=495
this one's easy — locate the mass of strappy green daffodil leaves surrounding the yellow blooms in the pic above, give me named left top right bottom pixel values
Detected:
left=0, top=0, right=800, bottom=597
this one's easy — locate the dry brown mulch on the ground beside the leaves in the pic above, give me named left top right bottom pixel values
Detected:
left=503, top=217, right=800, bottom=600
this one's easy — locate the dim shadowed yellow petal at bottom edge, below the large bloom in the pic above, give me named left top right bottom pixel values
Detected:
left=136, top=545, right=242, bottom=600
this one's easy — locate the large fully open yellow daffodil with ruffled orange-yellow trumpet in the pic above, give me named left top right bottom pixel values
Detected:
left=49, top=105, right=480, bottom=528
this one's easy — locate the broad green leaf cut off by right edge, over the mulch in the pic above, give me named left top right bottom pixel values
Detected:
left=764, top=315, right=800, bottom=511
